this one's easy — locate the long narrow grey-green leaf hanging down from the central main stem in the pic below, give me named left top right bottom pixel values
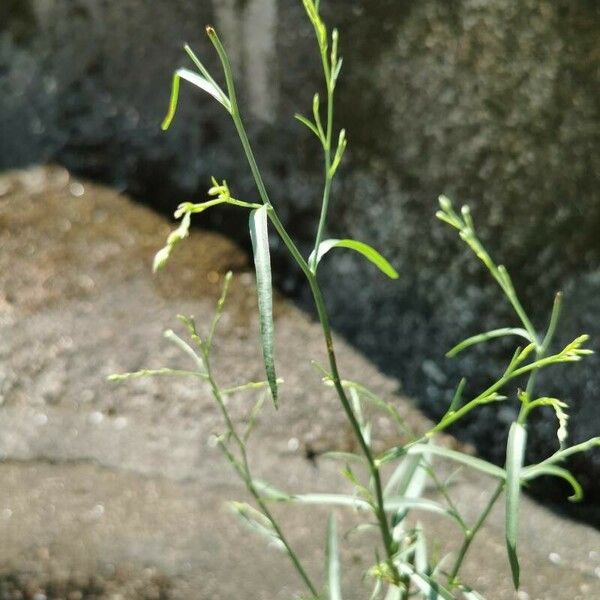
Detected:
left=250, top=206, right=277, bottom=408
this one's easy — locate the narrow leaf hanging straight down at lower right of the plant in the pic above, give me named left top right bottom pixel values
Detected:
left=506, top=423, right=527, bottom=589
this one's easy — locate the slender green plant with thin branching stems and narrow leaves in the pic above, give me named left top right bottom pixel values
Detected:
left=112, top=0, right=600, bottom=600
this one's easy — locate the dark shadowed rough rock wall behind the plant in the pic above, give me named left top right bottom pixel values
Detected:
left=0, top=0, right=600, bottom=501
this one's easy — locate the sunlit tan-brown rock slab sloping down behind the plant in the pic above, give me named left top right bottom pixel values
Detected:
left=0, top=169, right=600, bottom=600
